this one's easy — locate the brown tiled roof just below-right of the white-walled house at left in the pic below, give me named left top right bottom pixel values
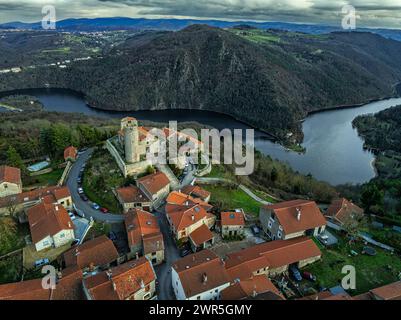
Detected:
left=63, top=235, right=118, bottom=269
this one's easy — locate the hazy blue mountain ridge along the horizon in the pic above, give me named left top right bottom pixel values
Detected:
left=0, top=17, right=401, bottom=41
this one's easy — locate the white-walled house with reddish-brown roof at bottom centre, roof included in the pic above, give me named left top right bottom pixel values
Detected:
left=171, top=249, right=230, bottom=300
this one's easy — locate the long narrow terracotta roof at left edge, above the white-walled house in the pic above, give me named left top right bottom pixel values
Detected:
left=0, top=186, right=71, bottom=208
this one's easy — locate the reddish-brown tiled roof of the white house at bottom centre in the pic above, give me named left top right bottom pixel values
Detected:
left=172, top=250, right=230, bottom=298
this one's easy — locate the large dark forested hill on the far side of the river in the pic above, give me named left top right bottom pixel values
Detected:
left=0, top=25, right=401, bottom=142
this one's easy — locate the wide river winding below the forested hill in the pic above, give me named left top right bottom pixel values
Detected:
left=2, top=89, right=401, bottom=185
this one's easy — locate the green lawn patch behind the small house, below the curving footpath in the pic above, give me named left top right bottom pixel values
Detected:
left=202, top=185, right=261, bottom=216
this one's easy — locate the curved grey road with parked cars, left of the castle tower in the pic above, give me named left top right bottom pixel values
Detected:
left=67, top=149, right=124, bottom=223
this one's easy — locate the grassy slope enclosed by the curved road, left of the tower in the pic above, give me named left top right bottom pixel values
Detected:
left=83, top=150, right=125, bottom=214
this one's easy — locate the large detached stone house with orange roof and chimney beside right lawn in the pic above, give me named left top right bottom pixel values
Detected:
left=259, top=200, right=326, bottom=240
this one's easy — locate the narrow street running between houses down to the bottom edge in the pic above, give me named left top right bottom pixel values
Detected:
left=153, top=206, right=181, bottom=300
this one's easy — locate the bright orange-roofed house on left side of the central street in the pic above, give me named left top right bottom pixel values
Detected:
left=125, top=209, right=164, bottom=265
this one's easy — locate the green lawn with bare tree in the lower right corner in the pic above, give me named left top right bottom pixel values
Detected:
left=305, top=232, right=401, bottom=295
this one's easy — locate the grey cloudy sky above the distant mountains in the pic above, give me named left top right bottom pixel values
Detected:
left=0, top=0, right=401, bottom=29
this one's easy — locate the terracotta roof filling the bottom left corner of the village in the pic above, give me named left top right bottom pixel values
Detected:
left=0, top=268, right=84, bottom=300
